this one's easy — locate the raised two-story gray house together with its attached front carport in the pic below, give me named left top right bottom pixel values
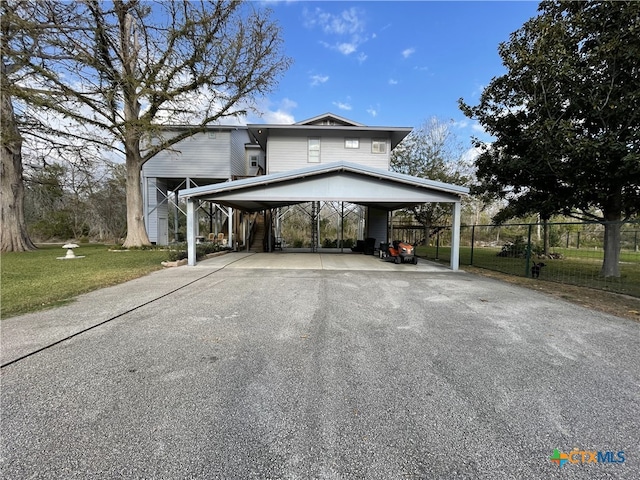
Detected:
left=143, top=114, right=468, bottom=268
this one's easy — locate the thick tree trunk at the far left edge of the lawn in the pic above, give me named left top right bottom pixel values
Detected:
left=0, top=75, right=36, bottom=252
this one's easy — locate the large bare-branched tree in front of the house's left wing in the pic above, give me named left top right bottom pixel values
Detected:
left=3, top=0, right=290, bottom=246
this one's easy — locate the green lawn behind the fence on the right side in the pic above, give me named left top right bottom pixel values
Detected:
left=417, top=247, right=640, bottom=297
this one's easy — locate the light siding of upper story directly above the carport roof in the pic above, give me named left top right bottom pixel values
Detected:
left=267, top=132, right=391, bottom=173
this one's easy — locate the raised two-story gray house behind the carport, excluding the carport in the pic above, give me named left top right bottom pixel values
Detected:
left=142, top=113, right=411, bottom=245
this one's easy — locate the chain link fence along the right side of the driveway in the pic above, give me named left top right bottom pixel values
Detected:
left=418, top=222, right=640, bottom=297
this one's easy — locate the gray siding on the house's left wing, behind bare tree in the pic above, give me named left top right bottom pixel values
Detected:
left=142, top=131, right=234, bottom=179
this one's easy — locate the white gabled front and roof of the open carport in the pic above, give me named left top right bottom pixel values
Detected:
left=179, top=162, right=469, bottom=212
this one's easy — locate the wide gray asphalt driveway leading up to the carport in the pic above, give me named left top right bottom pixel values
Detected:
left=0, top=254, right=640, bottom=479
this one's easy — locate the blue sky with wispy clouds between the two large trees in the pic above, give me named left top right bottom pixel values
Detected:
left=250, top=1, right=538, bottom=139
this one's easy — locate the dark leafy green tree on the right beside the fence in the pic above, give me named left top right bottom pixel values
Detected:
left=460, top=1, right=640, bottom=277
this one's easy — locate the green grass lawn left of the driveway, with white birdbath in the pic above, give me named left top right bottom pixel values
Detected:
left=0, top=244, right=167, bottom=318
